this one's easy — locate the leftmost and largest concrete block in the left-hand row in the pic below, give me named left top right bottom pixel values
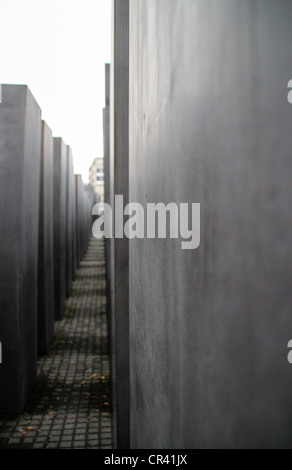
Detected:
left=0, top=85, right=41, bottom=413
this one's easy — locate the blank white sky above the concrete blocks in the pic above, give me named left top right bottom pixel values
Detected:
left=0, top=0, right=112, bottom=182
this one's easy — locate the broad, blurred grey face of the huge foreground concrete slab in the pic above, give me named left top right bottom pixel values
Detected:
left=129, top=0, right=292, bottom=448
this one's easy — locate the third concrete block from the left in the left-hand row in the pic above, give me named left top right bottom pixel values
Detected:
left=54, top=137, right=67, bottom=320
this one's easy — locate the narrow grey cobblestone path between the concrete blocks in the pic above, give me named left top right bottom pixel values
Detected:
left=0, top=238, right=111, bottom=449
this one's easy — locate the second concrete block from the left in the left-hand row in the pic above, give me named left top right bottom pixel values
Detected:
left=38, top=121, right=55, bottom=354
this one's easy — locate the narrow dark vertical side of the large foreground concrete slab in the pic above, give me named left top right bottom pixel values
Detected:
left=110, top=0, right=130, bottom=449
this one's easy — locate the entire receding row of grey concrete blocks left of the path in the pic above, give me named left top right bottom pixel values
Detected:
left=0, top=85, right=96, bottom=413
